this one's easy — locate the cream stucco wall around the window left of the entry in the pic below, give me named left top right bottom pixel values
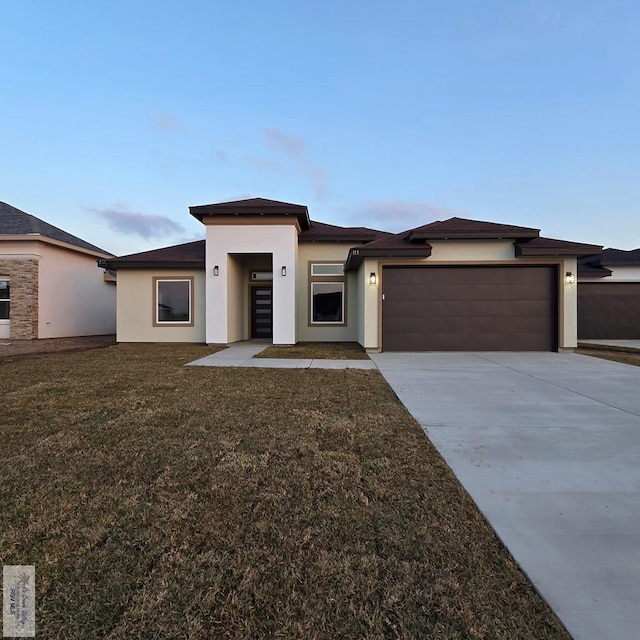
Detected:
left=116, top=269, right=205, bottom=343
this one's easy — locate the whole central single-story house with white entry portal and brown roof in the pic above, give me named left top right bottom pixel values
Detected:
left=105, top=198, right=602, bottom=351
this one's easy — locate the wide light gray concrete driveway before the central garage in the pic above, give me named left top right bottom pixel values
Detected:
left=372, top=353, right=640, bottom=640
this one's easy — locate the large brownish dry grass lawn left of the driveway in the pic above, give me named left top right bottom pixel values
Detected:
left=0, top=345, right=568, bottom=640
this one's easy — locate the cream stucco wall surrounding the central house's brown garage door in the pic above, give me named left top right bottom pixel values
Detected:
left=357, top=240, right=577, bottom=351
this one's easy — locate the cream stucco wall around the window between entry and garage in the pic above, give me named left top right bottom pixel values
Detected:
left=296, top=243, right=361, bottom=342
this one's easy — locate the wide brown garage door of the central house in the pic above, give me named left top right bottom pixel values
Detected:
left=382, top=266, right=557, bottom=351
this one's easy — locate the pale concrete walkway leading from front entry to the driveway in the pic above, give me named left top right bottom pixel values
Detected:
left=187, top=341, right=376, bottom=369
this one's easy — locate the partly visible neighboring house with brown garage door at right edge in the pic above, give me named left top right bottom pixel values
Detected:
left=578, top=249, right=640, bottom=340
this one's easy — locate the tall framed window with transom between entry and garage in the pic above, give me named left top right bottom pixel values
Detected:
left=309, top=262, right=346, bottom=325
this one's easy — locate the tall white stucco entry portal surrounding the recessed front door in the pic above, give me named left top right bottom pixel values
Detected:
left=205, top=221, right=298, bottom=344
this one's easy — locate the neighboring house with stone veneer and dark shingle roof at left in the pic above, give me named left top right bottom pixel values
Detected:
left=0, top=202, right=116, bottom=339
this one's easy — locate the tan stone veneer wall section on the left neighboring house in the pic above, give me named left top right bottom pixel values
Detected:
left=0, top=258, right=38, bottom=340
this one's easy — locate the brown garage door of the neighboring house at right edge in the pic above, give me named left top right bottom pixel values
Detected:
left=578, top=282, right=640, bottom=340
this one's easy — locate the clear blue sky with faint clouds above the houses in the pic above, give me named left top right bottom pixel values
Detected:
left=0, top=0, right=640, bottom=255
